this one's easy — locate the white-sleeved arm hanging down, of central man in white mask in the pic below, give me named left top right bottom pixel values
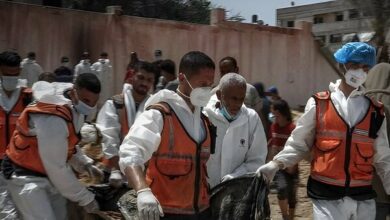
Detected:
left=119, top=110, right=164, bottom=191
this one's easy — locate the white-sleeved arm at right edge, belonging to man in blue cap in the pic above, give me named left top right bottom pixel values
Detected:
left=374, top=118, right=390, bottom=195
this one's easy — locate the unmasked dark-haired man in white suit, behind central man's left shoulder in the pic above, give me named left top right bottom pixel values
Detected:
left=96, top=61, right=157, bottom=187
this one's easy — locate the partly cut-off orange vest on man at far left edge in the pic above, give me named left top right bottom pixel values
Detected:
left=0, top=88, right=32, bottom=160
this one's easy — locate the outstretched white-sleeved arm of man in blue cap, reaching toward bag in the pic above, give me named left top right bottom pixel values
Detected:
left=273, top=98, right=316, bottom=168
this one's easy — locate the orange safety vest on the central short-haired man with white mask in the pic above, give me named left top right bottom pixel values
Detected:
left=146, top=103, right=211, bottom=215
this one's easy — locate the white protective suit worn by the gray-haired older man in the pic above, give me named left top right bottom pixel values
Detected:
left=203, top=95, right=267, bottom=188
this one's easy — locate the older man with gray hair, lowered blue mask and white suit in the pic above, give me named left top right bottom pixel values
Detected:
left=204, top=73, right=267, bottom=187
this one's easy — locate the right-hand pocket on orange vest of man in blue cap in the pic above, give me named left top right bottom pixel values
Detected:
left=354, top=143, right=374, bottom=173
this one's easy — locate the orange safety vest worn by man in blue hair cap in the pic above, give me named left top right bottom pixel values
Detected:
left=310, top=92, right=383, bottom=187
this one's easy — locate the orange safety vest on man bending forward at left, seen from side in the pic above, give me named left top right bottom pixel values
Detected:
left=6, top=102, right=79, bottom=175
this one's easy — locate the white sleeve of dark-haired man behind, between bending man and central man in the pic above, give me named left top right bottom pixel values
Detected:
left=96, top=100, right=121, bottom=159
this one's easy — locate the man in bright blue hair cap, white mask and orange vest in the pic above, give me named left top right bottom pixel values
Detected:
left=258, top=42, right=390, bottom=220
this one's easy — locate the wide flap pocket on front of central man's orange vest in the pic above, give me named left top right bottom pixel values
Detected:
left=156, top=159, right=192, bottom=178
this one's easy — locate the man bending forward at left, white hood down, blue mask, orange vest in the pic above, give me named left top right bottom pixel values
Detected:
left=2, top=73, right=103, bottom=220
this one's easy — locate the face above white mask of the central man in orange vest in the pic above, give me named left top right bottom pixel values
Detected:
left=179, top=68, right=215, bottom=96
